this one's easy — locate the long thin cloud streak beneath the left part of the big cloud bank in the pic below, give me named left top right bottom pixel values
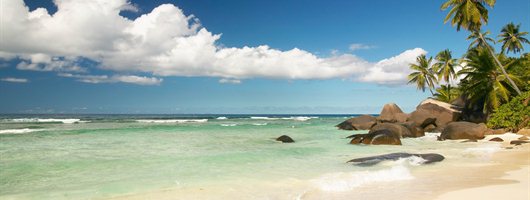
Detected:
left=58, top=73, right=163, bottom=85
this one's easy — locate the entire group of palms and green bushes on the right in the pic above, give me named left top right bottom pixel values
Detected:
left=408, top=0, right=530, bottom=131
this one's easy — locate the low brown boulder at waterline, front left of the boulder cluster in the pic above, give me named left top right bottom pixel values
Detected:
left=350, top=129, right=401, bottom=145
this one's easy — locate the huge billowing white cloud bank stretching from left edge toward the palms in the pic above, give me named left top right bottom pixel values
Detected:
left=0, top=0, right=427, bottom=85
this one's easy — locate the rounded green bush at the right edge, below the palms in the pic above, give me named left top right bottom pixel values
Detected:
left=488, top=92, right=530, bottom=132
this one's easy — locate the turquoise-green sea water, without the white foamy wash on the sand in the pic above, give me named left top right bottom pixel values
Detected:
left=0, top=116, right=502, bottom=199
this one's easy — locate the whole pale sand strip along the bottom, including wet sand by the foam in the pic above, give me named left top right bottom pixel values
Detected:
left=105, top=134, right=530, bottom=200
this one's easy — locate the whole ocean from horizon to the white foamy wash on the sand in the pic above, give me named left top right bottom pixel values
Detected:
left=0, top=115, right=508, bottom=199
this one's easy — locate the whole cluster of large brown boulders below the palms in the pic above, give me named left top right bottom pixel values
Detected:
left=336, top=99, right=500, bottom=145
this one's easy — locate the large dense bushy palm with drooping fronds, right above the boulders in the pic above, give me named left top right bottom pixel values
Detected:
left=458, top=47, right=520, bottom=114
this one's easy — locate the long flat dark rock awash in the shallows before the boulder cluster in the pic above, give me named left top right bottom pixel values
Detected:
left=348, top=153, right=445, bottom=166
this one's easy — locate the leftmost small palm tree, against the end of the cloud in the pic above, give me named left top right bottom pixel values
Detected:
left=408, top=54, right=437, bottom=95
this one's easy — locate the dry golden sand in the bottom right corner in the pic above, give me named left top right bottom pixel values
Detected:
left=429, top=138, right=530, bottom=200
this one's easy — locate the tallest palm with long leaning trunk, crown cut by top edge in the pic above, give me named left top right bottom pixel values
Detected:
left=441, top=0, right=521, bottom=94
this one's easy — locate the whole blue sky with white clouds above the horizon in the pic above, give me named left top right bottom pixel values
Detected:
left=0, top=0, right=530, bottom=114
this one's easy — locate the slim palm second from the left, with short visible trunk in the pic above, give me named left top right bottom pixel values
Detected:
left=433, top=49, right=456, bottom=99
